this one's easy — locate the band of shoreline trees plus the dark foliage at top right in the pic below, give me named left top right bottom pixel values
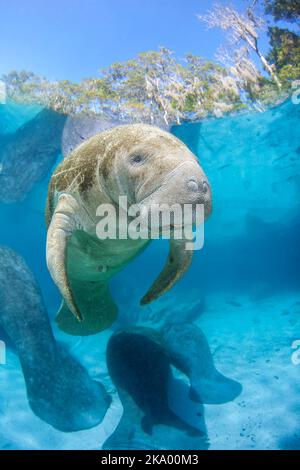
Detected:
left=2, top=0, right=300, bottom=125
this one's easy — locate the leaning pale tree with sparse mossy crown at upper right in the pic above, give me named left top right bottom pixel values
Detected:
left=198, top=2, right=281, bottom=88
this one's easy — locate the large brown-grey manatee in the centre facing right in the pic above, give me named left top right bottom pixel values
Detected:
left=46, top=124, right=211, bottom=335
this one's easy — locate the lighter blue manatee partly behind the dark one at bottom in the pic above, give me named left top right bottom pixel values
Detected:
left=161, top=323, right=242, bottom=404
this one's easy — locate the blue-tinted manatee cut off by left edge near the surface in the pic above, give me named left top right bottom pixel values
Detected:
left=0, top=109, right=66, bottom=203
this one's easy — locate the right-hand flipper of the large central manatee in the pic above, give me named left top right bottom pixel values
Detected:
left=141, top=239, right=193, bottom=305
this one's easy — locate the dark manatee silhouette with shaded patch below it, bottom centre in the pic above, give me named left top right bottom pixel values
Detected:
left=103, top=327, right=207, bottom=450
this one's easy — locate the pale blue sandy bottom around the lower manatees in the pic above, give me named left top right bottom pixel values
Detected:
left=0, top=294, right=300, bottom=449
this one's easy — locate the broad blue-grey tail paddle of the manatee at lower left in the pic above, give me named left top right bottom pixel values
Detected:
left=20, top=344, right=111, bottom=432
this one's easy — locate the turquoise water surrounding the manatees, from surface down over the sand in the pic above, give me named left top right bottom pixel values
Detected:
left=0, top=101, right=300, bottom=449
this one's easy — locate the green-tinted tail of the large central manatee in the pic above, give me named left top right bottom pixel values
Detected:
left=56, top=279, right=118, bottom=336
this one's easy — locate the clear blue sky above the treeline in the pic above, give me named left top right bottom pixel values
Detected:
left=0, top=0, right=276, bottom=80
